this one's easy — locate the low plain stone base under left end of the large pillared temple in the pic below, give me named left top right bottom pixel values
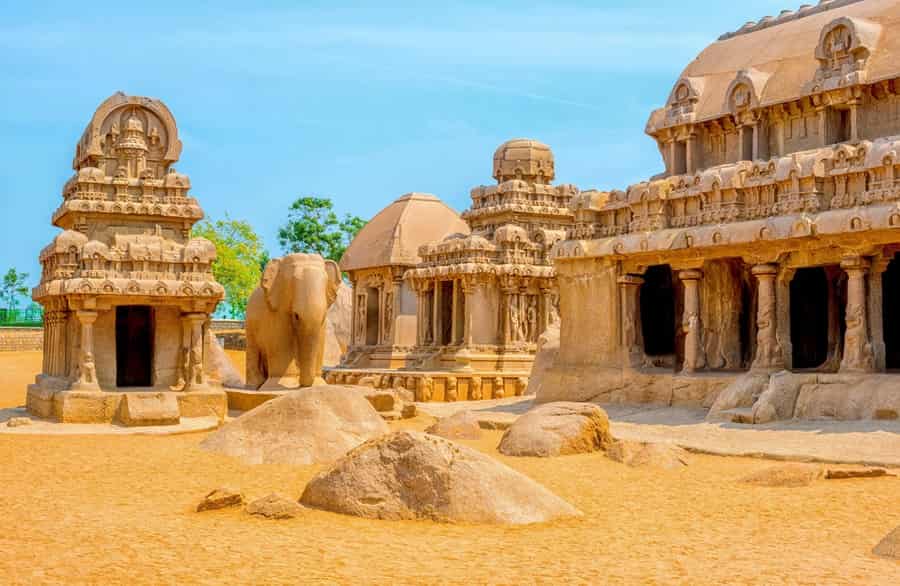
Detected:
left=536, top=366, right=741, bottom=408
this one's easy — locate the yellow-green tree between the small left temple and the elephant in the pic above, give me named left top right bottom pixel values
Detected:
left=193, top=216, right=268, bottom=319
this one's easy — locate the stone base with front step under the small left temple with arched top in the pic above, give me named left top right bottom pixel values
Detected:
left=26, top=384, right=228, bottom=427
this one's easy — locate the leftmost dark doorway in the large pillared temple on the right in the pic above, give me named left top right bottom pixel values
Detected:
left=641, top=265, right=675, bottom=356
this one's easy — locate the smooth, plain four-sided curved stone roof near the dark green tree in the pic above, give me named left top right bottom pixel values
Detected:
left=340, top=193, right=470, bottom=271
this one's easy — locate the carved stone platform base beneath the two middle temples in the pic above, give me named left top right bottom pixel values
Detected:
left=325, top=368, right=529, bottom=402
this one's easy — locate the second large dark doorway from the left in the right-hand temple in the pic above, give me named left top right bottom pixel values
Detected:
left=791, top=267, right=829, bottom=369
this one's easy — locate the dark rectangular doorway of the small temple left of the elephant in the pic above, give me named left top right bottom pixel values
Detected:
left=116, top=305, right=153, bottom=387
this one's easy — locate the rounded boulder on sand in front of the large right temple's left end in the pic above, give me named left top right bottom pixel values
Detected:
left=499, top=403, right=613, bottom=457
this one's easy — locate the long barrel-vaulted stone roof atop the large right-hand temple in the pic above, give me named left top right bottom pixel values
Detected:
left=647, top=0, right=900, bottom=134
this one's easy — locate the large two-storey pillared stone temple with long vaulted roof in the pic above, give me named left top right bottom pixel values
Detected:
left=539, top=0, right=900, bottom=423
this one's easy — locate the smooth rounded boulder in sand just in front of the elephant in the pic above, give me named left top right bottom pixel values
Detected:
left=200, top=385, right=388, bottom=464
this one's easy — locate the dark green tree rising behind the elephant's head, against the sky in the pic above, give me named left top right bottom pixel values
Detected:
left=278, top=196, right=366, bottom=262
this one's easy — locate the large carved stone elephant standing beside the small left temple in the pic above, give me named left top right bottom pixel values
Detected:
left=246, top=254, right=341, bottom=390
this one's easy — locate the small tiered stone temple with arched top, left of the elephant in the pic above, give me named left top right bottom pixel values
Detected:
left=28, top=93, right=226, bottom=425
